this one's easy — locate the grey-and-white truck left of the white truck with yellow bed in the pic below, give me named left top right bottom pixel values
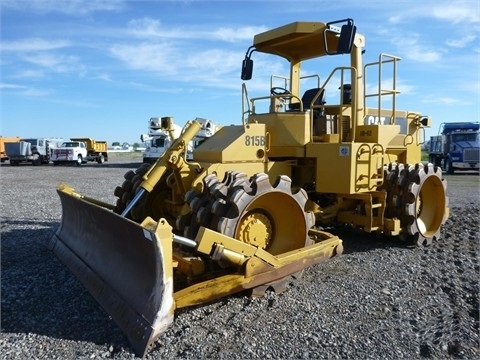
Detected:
left=5, top=138, right=63, bottom=166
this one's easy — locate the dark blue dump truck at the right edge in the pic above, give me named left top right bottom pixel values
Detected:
left=428, top=122, right=480, bottom=174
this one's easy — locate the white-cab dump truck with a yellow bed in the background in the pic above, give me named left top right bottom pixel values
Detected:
left=52, top=138, right=108, bottom=166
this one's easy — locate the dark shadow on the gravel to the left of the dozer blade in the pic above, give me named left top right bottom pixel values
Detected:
left=1, top=219, right=130, bottom=349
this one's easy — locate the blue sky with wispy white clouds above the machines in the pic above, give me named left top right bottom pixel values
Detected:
left=0, top=0, right=480, bottom=143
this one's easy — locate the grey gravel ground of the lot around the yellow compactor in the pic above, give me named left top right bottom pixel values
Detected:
left=0, top=156, right=480, bottom=359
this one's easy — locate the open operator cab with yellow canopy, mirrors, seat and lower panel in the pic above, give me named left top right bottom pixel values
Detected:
left=241, top=19, right=363, bottom=148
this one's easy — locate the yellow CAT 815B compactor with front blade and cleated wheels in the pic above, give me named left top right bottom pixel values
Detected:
left=50, top=19, right=449, bottom=356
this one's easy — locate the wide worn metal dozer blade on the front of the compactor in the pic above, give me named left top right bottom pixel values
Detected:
left=49, top=185, right=174, bottom=357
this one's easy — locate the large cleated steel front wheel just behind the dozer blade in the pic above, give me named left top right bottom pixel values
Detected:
left=176, top=172, right=315, bottom=255
